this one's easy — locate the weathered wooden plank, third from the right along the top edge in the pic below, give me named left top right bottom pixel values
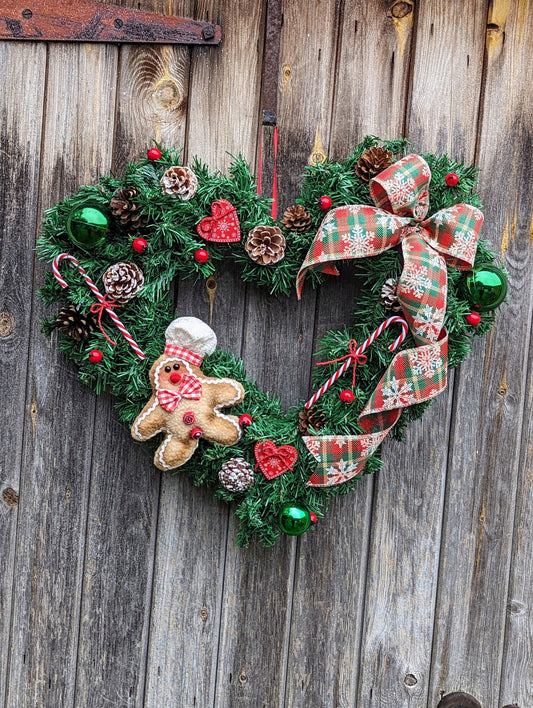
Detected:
left=286, top=2, right=411, bottom=706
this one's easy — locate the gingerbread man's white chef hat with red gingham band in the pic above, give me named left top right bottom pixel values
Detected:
left=165, top=317, right=217, bottom=366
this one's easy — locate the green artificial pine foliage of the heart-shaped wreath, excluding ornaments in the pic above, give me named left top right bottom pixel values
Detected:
left=37, top=136, right=494, bottom=546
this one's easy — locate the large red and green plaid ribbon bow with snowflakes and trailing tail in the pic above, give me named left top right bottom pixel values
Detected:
left=296, top=155, right=483, bottom=486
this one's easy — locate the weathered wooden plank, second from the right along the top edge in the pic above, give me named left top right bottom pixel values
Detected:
left=359, top=2, right=484, bottom=708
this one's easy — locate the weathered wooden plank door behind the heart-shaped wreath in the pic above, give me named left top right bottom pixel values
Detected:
left=0, top=0, right=533, bottom=708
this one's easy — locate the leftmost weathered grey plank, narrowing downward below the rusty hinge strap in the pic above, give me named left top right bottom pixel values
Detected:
left=0, top=44, right=46, bottom=705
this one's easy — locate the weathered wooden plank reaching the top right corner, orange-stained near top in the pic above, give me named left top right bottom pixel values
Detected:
left=430, top=2, right=533, bottom=706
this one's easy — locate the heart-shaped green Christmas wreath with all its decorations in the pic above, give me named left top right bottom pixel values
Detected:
left=38, top=137, right=506, bottom=545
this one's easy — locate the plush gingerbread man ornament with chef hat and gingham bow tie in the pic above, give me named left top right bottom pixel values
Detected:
left=131, top=317, right=244, bottom=470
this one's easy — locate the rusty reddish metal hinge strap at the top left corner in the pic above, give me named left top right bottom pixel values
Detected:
left=0, top=0, right=222, bottom=45
